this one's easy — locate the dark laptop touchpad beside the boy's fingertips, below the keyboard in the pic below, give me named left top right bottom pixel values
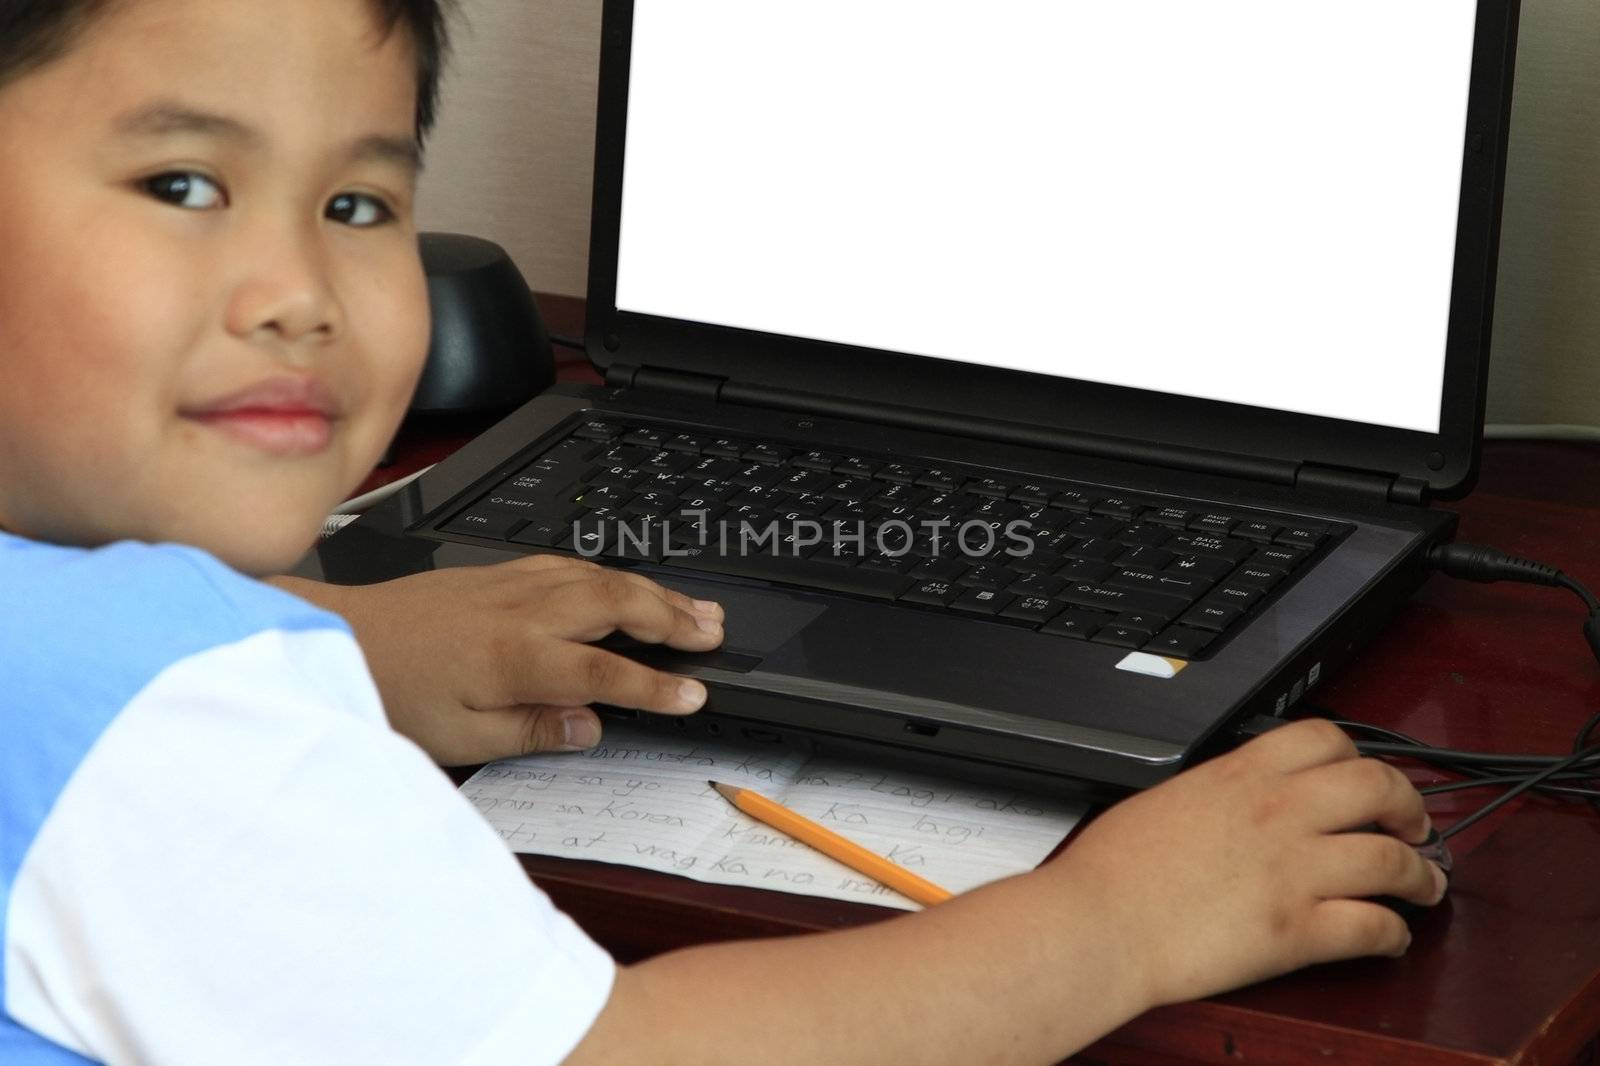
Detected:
left=600, top=571, right=827, bottom=674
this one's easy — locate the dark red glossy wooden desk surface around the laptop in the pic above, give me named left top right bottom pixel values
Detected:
left=378, top=298, right=1600, bottom=1066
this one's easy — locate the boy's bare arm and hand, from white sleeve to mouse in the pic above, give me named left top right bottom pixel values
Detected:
left=568, top=722, right=1443, bottom=1066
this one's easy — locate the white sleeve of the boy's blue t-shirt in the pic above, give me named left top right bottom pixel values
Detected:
left=5, top=631, right=614, bottom=1066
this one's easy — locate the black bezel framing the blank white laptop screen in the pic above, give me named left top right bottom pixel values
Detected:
left=586, top=0, right=1520, bottom=498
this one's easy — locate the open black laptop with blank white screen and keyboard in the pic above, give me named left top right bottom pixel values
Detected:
left=302, top=0, right=1518, bottom=794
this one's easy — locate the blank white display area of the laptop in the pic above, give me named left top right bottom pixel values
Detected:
left=616, top=0, right=1477, bottom=432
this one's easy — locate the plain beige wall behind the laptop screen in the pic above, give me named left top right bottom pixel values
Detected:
left=421, top=0, right=1600, bottom=424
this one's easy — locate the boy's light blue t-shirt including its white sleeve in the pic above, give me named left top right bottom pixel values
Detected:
left=0, top=535, right=614, bottom=1066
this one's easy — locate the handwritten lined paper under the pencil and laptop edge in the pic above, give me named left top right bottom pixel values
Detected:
left=461, top=722, right=1085, bottom=911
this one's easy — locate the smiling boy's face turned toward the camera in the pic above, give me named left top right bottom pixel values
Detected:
left=0, top=0, right=429, bottom=573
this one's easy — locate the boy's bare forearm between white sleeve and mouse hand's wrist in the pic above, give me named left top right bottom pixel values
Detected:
left=568, top=871, right=1147, bottom=1066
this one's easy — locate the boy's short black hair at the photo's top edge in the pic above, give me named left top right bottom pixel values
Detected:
left=0, top=0, right=453, bottom=142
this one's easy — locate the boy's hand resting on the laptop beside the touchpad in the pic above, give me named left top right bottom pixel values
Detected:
left=274, top=555, right=723, bottom=765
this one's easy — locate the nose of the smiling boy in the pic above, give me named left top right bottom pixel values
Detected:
left=227, top=237, right=342, bottom=349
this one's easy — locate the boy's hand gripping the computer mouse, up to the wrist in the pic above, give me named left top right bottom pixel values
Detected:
left=1045, top=720, right=1445, bottom=1005
